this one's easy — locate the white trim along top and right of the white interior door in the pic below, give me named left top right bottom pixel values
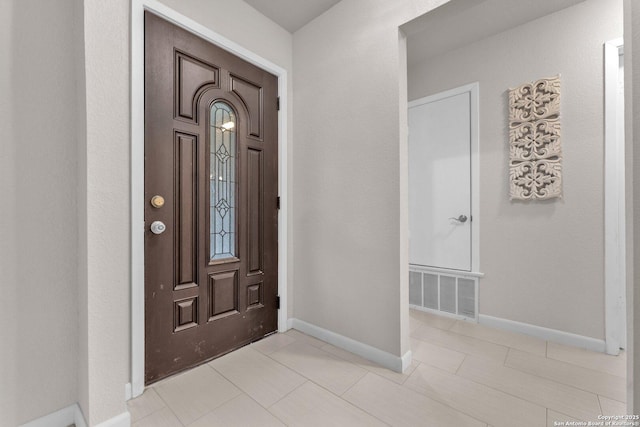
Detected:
left=407, top=82, right=480, bottom=272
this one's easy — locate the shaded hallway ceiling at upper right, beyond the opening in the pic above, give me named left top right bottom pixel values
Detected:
left=402, top=0, right=584, bottom=65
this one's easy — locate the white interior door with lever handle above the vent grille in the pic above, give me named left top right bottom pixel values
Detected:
left=409, top=91, right=472, bottom=271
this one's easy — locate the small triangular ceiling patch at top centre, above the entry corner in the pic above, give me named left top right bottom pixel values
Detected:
left=245, top=0, right=340, bottom=33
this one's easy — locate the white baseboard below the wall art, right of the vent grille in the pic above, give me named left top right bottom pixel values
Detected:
left=478, top=314, right=605, bottom=353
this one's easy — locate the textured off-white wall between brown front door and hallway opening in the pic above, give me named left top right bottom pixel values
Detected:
left=293, top=0, right=444, bottom=356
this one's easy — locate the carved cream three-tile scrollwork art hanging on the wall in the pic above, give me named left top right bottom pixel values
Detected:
left=509, top=75, right=562, bottom=200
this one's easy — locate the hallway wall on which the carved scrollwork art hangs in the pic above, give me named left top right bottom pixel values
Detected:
left=408, top=0, right=623, bottom=339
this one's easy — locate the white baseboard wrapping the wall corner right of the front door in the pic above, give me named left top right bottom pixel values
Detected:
left=289, top=319, right=411, bottom=372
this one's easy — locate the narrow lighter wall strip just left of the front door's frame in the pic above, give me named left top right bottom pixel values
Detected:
left=78, top=0, right=130, bottom=425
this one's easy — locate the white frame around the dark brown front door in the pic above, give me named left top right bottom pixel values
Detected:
left=130, top=0, right=288, bottom=399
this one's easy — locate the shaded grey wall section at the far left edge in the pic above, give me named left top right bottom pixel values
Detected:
left=0, top=0, right=78, bottom=426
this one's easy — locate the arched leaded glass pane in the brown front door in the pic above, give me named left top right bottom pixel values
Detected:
left=209, top=101, right=237, bottom=261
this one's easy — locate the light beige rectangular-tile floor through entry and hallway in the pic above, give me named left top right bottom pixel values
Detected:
left=128, top=311, right=626, bottom=427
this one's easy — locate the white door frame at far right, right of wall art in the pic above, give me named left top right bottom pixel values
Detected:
left=604, top=39, right=628, bottom=355
